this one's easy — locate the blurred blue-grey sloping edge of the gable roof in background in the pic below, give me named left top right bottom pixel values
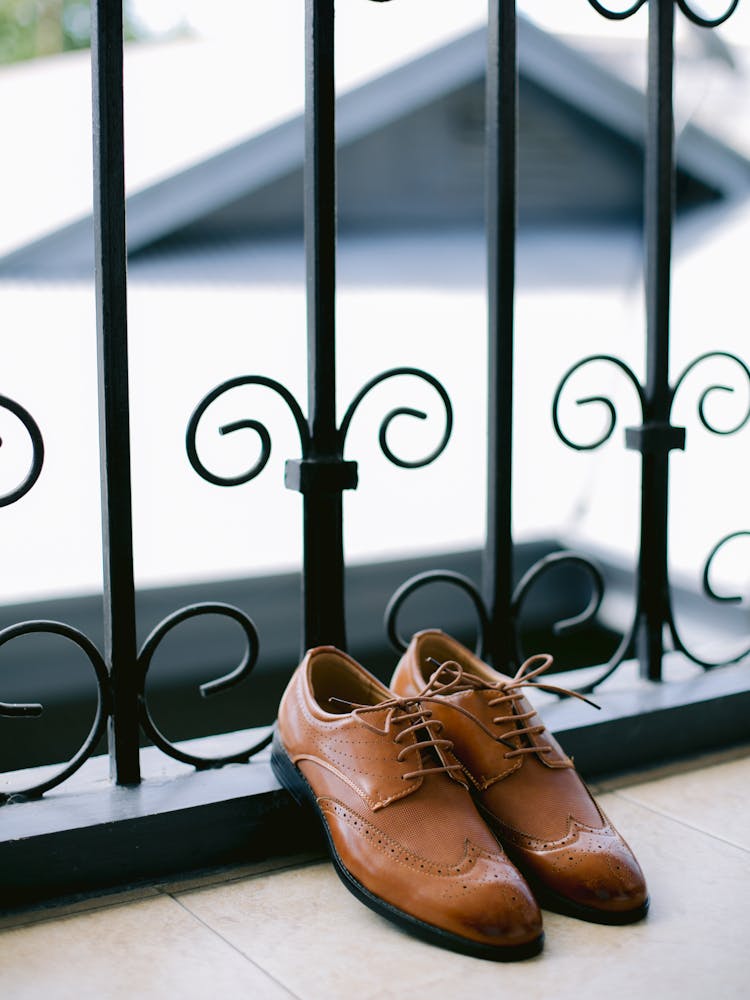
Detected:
left=0, top=19, right=750, bottom=274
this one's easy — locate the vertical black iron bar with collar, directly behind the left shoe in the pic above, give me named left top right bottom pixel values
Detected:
left=302, top=0, right=346, bottom=648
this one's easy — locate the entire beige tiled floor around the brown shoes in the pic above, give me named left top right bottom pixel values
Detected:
left=0, top=755, right=750, bottom=1000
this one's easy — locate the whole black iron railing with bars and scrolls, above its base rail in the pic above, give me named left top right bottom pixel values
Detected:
left=0, top=0, right=750, bottom=860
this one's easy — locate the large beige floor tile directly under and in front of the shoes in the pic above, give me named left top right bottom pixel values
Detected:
left=179, top=795, right=750, bottom=1000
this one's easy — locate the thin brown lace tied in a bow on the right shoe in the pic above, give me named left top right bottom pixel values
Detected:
left=419, top=653, right=601, bottom=760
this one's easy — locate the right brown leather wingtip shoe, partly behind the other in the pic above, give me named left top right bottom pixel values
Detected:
left=391, top=630, right=648, bottom=924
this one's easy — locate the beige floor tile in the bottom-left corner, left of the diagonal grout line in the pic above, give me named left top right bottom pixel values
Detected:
left=0, top=896, right=290, bottom=1000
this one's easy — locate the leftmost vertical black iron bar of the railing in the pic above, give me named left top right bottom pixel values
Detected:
left=91, top=0, right=140, bottom=785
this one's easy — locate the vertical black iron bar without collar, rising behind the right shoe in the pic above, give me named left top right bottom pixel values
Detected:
left=484, top=0, right=518, bottom=670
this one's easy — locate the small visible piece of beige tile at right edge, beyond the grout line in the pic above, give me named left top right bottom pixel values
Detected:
left=617, top=755, right=750, bottom=851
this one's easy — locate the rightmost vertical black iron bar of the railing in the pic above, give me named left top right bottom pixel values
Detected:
left=635, top=0, right=675, bottom=680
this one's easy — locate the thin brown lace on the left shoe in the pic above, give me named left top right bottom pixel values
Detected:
left=328, top=696, right=463, bottom=781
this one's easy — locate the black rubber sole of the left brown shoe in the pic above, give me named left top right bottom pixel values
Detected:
left=271, top=731, right=544, bottom=962
